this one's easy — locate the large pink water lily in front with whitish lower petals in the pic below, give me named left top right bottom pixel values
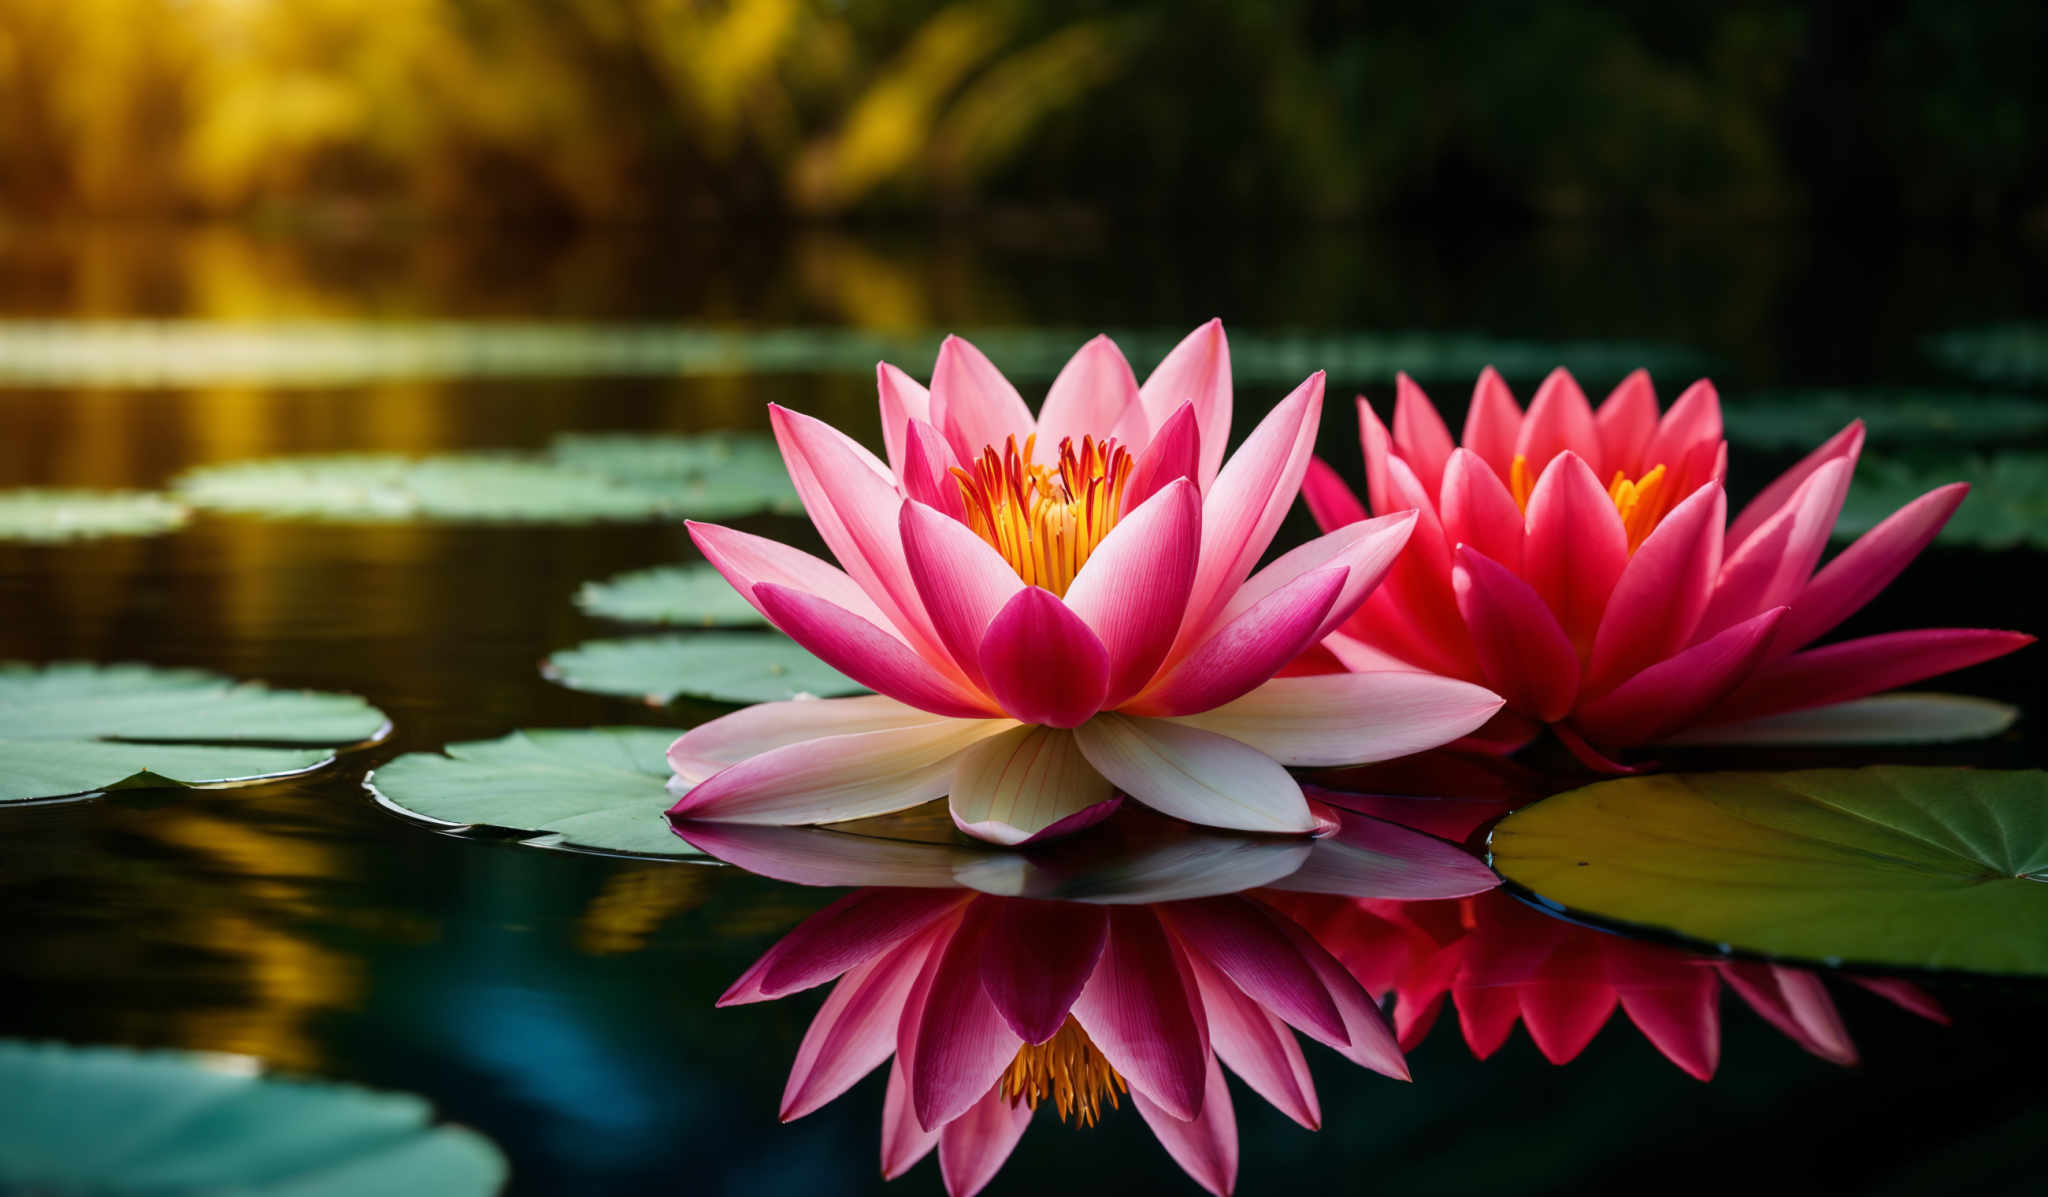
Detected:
left=670, top=322, right=1499, bottom=842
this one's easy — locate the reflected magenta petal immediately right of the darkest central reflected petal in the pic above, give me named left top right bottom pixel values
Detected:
left=1073, top=906, right=1208, bottom=1119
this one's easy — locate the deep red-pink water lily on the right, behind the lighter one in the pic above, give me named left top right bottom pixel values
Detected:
left=1303, top=369, right=2034, bottom=769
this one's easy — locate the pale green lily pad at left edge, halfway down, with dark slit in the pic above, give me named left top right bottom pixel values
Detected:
left=0, top=662, right=389, bottom=801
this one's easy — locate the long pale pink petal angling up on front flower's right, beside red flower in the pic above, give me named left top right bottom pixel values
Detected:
left=1180, top=373, right=1323, bottom=644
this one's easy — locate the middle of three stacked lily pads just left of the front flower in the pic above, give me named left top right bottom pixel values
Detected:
left=541, top=631, right=866, bottom=705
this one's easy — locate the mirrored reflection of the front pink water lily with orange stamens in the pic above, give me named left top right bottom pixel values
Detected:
left=719, top=879, right=1425, bottom=1197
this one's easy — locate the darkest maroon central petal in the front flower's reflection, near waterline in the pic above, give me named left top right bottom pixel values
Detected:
left=981, top=898, right=1110, bottom=1043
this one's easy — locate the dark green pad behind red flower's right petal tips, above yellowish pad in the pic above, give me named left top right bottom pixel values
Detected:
left=1835, top=453, right=2048, bottom=549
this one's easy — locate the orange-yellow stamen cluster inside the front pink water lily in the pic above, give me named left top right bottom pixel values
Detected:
left=952, top=437, right=1133, bottom=594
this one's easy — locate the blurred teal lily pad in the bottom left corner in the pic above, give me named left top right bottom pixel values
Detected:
left=0, top=1041, right=508, bottom=1197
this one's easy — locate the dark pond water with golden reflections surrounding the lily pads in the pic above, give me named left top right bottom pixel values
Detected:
left=0, top=219, right=2048, bottom=1193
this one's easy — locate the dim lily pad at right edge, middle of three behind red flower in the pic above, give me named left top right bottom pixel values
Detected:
left=1722, top=389, right=2048, bottom=451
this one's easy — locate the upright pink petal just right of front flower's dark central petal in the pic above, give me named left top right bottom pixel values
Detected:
left=1067, top=478, right=1202, bottom=707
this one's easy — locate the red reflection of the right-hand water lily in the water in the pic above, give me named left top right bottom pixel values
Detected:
left=1286, top=892, right=1948, bottom=1080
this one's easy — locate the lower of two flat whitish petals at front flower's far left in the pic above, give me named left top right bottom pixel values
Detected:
left=668, top=705, right=1010, bottom=824
